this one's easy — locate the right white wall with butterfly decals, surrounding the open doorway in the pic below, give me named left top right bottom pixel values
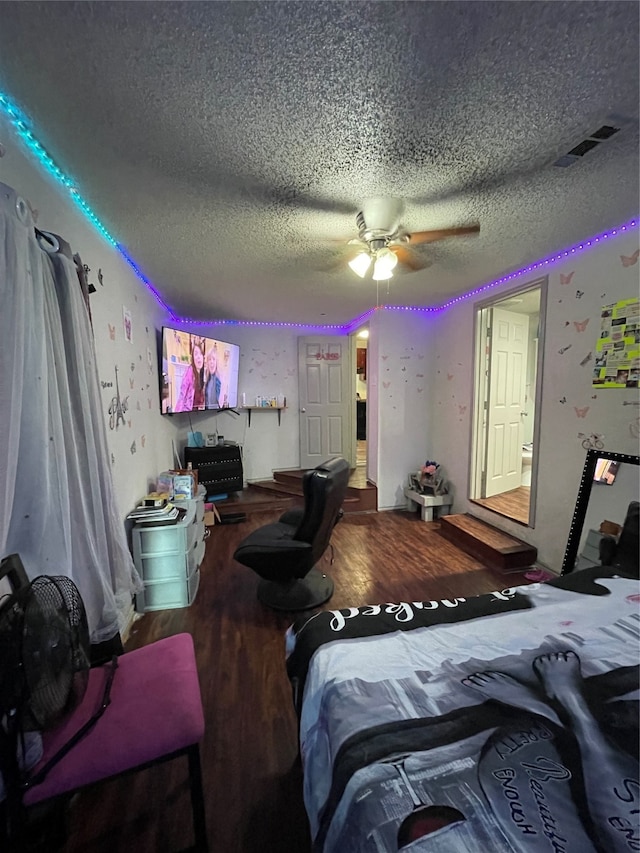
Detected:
left=428, top=232, right=640, bottom=570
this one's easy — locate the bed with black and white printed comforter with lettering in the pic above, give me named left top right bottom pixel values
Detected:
left=287, top=566, right=640, bottom=853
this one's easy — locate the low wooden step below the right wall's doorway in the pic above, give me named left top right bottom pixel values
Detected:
left=439, top=513, right=538, bottom=572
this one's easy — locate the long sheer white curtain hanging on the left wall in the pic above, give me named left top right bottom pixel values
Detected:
left=0, top=183, right=141, bottom=642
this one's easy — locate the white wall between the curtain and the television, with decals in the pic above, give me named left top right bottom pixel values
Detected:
left=0, top=114, right=175, bottom=518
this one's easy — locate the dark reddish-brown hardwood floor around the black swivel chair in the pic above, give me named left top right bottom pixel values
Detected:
left=58, top=512, right=528, bottom=853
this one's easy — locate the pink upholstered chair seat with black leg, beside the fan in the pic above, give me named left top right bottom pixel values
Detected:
left=24, top=634, right=207, bottom=851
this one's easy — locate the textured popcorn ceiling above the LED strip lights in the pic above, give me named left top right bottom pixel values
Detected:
left=0, top=2, right=639, bottom=323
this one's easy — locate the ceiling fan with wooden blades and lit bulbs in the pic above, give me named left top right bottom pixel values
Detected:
left=340, top=198, right=480, bottom=281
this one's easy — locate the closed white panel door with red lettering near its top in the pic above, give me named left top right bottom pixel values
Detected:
left=298, top=335, right=352, bottom=469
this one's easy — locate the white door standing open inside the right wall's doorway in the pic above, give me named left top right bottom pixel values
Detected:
left=484, top=307, right=529, bottom=498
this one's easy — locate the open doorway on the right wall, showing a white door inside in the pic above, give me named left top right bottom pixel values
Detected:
left=469, top=278, right=547, bottom=527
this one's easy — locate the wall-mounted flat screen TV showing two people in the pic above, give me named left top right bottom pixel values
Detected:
left=160, top=326, right=240, bottom=415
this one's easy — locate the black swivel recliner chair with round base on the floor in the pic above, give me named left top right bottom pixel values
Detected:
left=233, top=456, right=350, bottom=611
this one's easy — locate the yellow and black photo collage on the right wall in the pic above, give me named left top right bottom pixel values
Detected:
left=593, top=292, right=640, bottom=388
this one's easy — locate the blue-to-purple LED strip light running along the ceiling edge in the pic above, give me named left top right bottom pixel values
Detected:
left=0, top=92, right=638, bottom=334
